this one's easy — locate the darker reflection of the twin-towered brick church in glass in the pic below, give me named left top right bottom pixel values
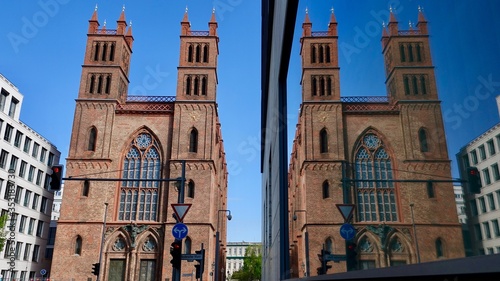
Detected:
left=289, top=8, right=464, bottom=277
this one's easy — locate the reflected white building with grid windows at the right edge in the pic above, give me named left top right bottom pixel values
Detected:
left=457, top=97, right=500, bottom=255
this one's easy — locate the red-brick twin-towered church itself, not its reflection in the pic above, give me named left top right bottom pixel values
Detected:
left=51, top=10, right=227, bottom=281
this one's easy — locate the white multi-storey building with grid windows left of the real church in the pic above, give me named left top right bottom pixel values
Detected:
left=0, top=75, right=60, bottom=280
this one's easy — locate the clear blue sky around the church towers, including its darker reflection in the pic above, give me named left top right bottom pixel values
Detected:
left=0, top=0, right=500, bottom=241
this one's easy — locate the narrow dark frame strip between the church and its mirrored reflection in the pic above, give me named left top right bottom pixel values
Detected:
left=261, top=0, right=299, bottom=280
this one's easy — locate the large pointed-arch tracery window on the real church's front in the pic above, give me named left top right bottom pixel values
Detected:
left=118, top=132, right=161, bottom=221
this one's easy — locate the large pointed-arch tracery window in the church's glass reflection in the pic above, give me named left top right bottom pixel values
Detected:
left=354, top=132, right=398, bottom=221
